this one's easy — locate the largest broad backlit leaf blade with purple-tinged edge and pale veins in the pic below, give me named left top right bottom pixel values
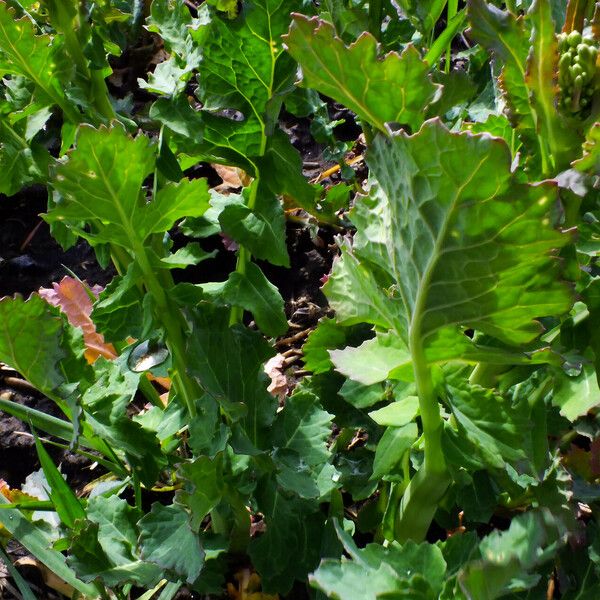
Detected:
left=346, top=121, right=571, bottom=346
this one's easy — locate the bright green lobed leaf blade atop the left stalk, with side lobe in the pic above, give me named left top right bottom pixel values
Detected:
left=46, top=126, right=209, bottom=251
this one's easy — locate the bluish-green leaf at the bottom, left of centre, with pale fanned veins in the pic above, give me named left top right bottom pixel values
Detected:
left=138, top=502, right=204, bottom=583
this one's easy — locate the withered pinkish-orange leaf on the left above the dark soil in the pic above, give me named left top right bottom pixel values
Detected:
left=39, top=277, right=117, bottom=364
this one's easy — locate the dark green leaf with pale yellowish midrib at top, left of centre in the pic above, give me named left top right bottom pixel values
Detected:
left=151, top=0, right=306, bottom=165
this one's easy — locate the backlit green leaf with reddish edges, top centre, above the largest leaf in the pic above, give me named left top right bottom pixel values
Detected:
left=284, top=15, right=436, bottom=131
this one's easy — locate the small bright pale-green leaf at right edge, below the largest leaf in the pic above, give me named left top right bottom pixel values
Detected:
left=552, top=363, right=600, bottom=422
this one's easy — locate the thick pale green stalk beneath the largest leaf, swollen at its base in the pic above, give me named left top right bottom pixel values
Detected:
left=395, top=327, right=451, bottom=542
